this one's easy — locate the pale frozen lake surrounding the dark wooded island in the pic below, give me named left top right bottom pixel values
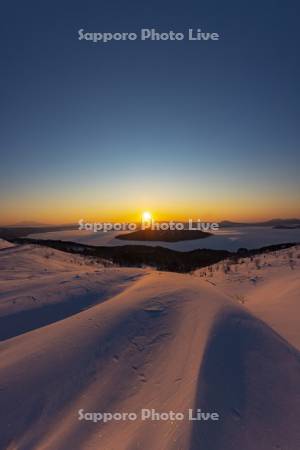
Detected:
left=28, top=227, right=300, bottom=251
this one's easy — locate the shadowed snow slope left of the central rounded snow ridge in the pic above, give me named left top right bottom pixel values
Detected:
left=0, top=245, right=144, bottom=340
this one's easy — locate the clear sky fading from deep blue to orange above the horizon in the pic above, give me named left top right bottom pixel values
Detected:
left=0, top=0, right=300, bottom=224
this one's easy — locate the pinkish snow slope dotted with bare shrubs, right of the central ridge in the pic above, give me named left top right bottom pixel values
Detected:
left=195, top=246, right=300, bottom=349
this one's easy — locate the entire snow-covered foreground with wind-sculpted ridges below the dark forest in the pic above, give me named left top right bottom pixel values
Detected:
left=0, top=246, right=300, bottom=450
